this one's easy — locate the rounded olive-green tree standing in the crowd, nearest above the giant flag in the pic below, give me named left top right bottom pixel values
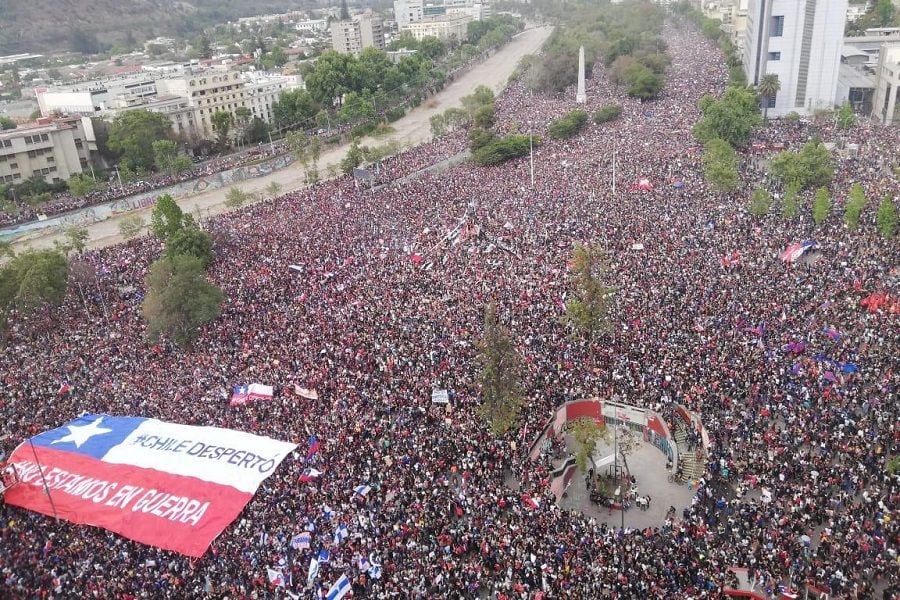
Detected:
left=142, top=256, right=225, bottom=347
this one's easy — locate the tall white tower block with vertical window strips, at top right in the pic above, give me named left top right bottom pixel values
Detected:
left=743, top=0, right=847, bottom=117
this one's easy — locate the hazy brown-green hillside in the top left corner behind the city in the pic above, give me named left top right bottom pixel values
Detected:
left=0, top=0, right=308, bottom=54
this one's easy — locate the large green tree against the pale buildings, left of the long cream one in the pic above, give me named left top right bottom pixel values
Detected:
left=107, top=110, right=172, bottom=171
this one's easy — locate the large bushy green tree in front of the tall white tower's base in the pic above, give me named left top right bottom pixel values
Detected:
left=694, top=87, right=762, bottom=147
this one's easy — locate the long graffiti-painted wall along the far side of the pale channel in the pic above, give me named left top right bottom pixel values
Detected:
left=0, top=154, right=294, bottom=241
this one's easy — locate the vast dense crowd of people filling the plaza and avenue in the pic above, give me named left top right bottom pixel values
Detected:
left=0, top=15, right=900, bottom=600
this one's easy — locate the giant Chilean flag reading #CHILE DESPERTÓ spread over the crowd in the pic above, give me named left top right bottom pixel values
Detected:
left=6, top=415, right=296, bottom=556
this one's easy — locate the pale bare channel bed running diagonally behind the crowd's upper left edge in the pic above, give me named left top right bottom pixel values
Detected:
left=15, top=27, right=552, bottom=250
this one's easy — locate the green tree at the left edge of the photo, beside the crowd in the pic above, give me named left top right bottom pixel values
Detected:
left=0, top=250, right=69, bottom=327
